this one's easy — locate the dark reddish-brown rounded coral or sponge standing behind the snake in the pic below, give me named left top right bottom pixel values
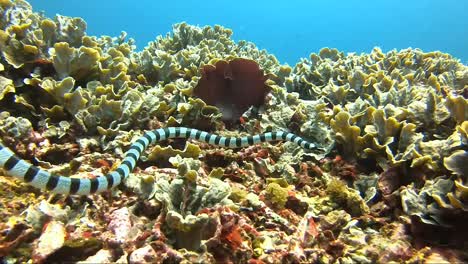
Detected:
left=194, top=58, right=271, bottom=122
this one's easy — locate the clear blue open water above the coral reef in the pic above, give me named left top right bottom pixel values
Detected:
left=29, top=0, right=468, bottom=65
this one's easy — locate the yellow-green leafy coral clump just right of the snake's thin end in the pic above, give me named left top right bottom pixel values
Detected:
left=330, top=105, right=458, bottom=170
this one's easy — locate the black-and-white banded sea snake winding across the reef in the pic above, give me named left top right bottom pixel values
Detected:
left=0, top=127, right=315, bottom=195
